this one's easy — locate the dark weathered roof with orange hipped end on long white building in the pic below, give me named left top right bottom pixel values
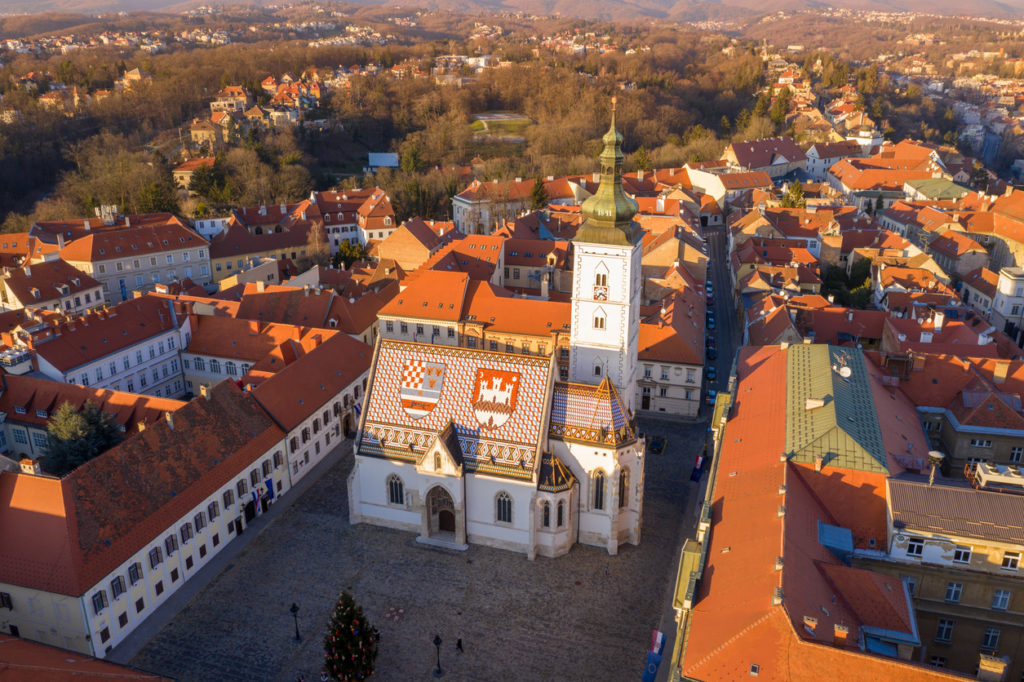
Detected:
left=0, top=381, right=285, bottom=597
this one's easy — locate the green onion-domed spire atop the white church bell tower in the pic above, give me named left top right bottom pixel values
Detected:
left=573, top=97, right=640, bottom=246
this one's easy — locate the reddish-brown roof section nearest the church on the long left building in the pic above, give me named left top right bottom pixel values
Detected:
left=252, top=327, right=374, bottom=431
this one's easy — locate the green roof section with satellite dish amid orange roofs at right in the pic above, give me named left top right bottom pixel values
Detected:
left=785, top=344, right=889, bottom=473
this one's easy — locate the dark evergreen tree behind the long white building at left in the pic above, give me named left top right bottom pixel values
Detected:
left=42, top=401, right=121, bottom=476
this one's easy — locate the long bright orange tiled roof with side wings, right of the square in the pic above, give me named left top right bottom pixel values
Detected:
left=680, top=346, right=955, bottom=682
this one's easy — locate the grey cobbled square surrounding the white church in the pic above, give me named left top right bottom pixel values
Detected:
left=130, top=413, right=706, bottom=682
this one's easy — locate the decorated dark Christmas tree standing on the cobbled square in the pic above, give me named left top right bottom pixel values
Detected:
left=324, top=592, right=377, bottom=682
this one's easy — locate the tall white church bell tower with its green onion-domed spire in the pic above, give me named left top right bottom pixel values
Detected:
left=569, top=98, right=643, bottom=413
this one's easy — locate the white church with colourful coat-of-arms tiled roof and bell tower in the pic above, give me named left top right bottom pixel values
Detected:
left=348, top=107, right=644, bottom=559
